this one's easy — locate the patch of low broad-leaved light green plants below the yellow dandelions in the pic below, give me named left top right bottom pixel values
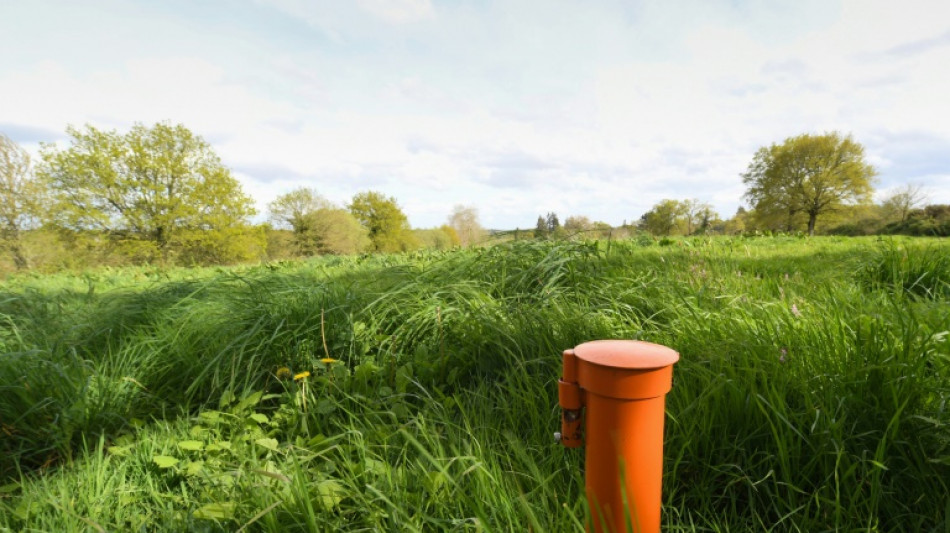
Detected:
left=107, top=380, right=343, bottom=521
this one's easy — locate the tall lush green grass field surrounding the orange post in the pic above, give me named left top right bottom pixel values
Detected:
left=0, top=237, right=950, bottom=533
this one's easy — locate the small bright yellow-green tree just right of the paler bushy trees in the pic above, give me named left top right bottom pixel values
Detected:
left=348, top=191, right=418, bottom=252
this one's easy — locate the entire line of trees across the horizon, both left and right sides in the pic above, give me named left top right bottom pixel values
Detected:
left=0, top=123, right=950, bottom=270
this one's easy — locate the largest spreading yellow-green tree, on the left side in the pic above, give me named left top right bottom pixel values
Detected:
left=40, top=123, right=254, bottom=255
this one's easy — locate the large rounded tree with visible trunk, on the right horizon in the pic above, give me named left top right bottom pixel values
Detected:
left=742, top=132, right=875, bottom=235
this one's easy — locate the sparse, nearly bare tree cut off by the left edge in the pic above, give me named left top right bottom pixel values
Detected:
left=0, top=134, right=44, bottom=270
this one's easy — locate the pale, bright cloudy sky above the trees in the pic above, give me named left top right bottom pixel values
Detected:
left=0, top=0, right=950, bottom=229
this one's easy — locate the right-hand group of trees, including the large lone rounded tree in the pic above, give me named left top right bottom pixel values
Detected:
left=638, top=132, right=950, bottom=236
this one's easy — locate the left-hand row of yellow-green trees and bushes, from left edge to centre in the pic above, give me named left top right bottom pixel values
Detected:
left=0, top=123, right=484, bottom=270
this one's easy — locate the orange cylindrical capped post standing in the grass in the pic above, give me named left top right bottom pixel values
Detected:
left=555, top=340, right=679, bottom=533
